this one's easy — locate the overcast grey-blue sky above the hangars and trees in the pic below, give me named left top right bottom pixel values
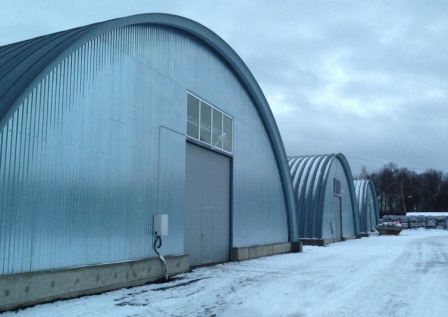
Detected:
left=0, top=0, right=448, bottom=175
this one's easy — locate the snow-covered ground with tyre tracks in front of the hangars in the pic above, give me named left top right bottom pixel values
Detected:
left=0, top=229, right=448, bottom=317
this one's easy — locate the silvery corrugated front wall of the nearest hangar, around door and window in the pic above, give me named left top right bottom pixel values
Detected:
left=0, top=25, right=288, bottom=274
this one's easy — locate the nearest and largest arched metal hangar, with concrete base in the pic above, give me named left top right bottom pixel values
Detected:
left=0, top=14, right=300, bottom=310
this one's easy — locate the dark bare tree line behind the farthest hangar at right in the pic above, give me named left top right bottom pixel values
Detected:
left=359, top=163, right=448, bottom=217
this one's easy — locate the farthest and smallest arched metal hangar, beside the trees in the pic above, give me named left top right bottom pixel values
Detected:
left=354, top=179, right=379, bottom=233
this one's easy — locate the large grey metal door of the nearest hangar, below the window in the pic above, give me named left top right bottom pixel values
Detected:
left=184, top=143, right=230, bottom=266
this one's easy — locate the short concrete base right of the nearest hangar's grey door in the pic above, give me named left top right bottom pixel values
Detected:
left=231, top=242, right=302, bottom=261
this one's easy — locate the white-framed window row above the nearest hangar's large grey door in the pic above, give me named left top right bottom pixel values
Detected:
left=187, top=93, right=233, bottom=153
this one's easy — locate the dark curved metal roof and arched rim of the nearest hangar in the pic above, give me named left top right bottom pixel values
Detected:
left=0, top=13, right=298, bottom=241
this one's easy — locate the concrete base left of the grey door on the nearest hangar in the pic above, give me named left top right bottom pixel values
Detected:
left=0, top=255, right=190, bottom=312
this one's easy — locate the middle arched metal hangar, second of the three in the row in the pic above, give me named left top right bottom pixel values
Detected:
left=288, top=154, right=360, bottom=245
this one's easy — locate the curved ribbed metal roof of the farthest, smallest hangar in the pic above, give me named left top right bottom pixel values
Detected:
left=354, top=179, right=379, bottom=232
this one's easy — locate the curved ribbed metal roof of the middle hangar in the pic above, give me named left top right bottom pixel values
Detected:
left=288, top=153, right=359, bottom=237
